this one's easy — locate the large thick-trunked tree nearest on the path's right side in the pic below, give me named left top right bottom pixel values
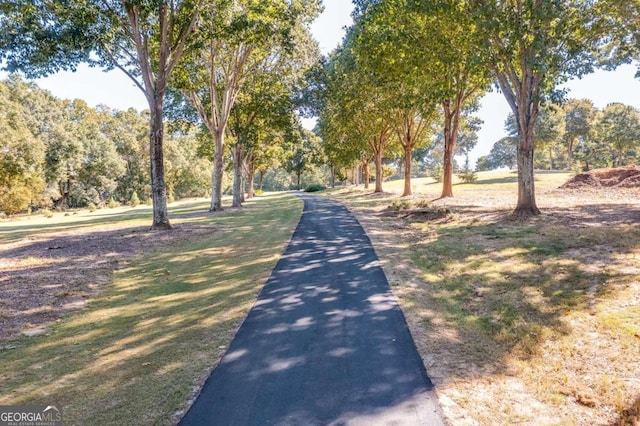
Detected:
left=470, top=0, right=603, bottom=217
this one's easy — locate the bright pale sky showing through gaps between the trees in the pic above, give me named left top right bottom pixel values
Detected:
left=0, top=0, right=640, bottom=164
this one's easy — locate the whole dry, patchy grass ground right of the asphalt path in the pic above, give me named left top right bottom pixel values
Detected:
left=334, top=173, right=640, bottom=425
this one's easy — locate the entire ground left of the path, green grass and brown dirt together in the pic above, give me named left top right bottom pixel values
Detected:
left=0, top=194, right=302, bottom=425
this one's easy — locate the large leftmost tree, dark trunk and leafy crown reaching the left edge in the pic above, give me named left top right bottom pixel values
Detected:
left=0, top=0, right=204, bottom=229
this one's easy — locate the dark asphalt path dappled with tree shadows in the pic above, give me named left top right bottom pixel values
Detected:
left=180, top=195, right=444, bottom=426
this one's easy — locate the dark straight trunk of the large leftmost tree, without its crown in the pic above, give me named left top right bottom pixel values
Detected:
left=149, top=98, right=171, bottom=229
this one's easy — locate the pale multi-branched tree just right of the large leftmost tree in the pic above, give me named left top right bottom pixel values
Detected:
left=176, top=0, right=320, bottom=211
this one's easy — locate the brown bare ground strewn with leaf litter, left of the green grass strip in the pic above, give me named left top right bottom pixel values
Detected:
left=0, top=213, right=215, bottom=344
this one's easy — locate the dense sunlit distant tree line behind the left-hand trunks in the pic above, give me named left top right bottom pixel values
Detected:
left=0, top=75, right=318, bottom=215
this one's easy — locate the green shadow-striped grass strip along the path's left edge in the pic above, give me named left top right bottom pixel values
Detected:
left=0, top=195, right=302, bottom=425
